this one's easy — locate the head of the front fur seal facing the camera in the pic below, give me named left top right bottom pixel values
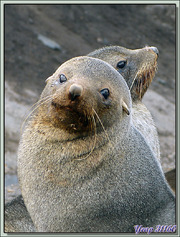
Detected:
left=40, top=56, right=131, bottom=139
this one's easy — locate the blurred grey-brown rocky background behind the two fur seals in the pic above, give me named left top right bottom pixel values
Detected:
left=4, top=4, right=176, bottom=201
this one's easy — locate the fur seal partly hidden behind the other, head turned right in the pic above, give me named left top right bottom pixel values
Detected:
left=88, top=46, right=160, bottom=160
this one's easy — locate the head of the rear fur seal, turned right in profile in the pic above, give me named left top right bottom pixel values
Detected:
left=88, top=46, right=159, bottom=101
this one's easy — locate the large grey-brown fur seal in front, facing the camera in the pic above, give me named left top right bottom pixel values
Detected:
left=18, top=57, right=175, bottom=232
